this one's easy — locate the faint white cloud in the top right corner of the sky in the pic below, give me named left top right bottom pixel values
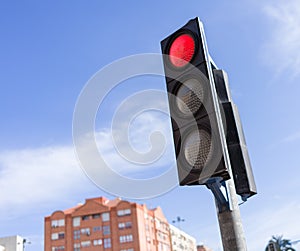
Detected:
left=262, top=0, right=300, bottom=78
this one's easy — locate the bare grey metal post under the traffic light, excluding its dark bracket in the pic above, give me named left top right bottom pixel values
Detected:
left=216, top=177, right=247, bottom=251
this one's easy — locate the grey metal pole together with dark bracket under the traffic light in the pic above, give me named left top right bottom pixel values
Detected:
left=207, top=179, right=247, bottom=251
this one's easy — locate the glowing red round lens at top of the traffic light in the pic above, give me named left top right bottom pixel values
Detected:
left=169, top=34, right=195, bottom=68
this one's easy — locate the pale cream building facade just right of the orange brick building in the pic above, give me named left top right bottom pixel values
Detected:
left=169, top=225, right=197, bottom=251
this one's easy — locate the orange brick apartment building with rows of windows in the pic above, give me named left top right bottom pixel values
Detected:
left=45, top=197, right=171, bottom=251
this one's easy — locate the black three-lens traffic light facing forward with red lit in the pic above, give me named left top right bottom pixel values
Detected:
left=161, top=18, right=230, bottom=185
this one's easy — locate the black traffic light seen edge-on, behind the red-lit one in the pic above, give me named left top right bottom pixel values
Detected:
left=213, top=69, right=257, bottom=199
